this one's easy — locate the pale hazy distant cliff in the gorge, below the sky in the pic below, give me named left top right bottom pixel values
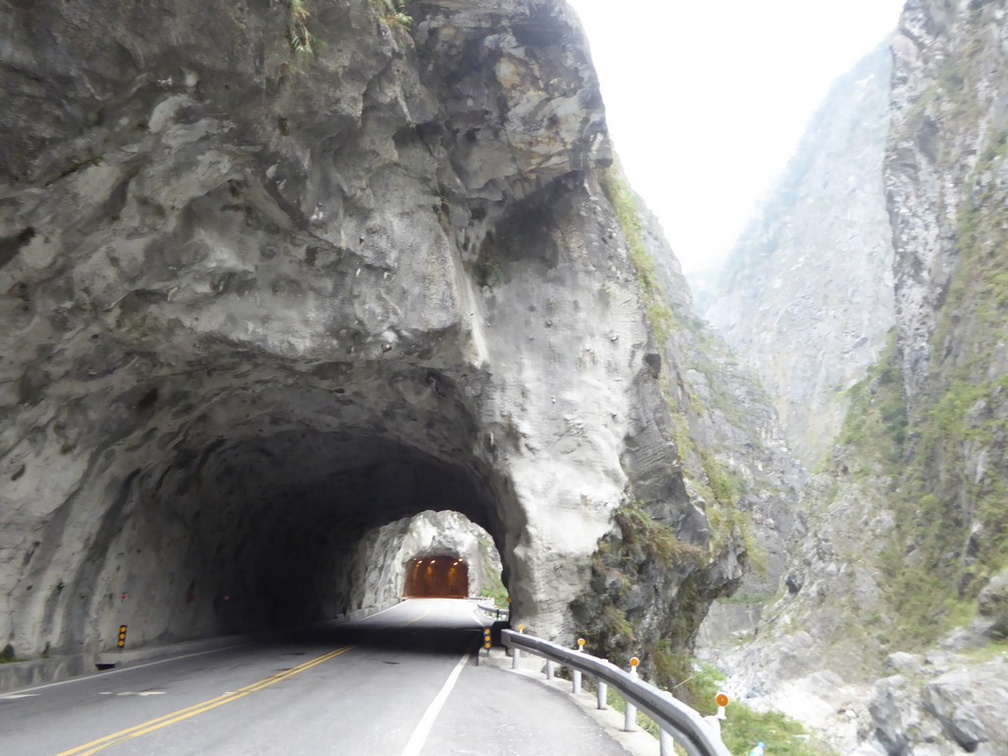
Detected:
left=705, top=44, right=895, bottom=468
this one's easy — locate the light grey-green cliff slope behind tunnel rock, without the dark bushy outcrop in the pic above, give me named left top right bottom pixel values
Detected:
left=620, top=204, right=807, bottom=657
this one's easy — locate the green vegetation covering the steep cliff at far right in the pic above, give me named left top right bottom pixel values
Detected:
left=841, top=126, right=1008, bottom=644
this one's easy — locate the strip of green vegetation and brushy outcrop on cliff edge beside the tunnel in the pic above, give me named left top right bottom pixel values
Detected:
left=572, top=164, right=764, bottom=669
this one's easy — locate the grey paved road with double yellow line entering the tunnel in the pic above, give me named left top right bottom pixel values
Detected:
left=0, top=600, right=625, bottom=756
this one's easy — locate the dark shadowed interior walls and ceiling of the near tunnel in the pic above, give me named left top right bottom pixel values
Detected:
left=78, top=376, right=508, bottom=643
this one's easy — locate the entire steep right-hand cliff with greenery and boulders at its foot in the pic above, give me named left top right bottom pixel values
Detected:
left=705, top=0, right=1008, bottom=755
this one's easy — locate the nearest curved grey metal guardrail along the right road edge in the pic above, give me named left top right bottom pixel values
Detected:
left=501, top=630, right=732, bottom=756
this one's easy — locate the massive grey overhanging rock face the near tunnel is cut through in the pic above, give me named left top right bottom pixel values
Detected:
left=0, top=0, right=742, bottom=673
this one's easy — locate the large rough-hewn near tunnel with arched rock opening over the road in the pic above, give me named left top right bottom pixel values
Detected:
left=38, top=369, right=520, bottom=647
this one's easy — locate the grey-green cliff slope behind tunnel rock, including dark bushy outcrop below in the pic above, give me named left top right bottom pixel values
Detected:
left=574, top=168, right=805, bottom=685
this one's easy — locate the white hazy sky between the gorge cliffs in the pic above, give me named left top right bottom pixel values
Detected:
left=569, top=0, right=903, bottom=271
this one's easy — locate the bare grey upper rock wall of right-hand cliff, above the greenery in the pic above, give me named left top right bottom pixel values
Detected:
left=886, top=0, right=1008, bottom=412
